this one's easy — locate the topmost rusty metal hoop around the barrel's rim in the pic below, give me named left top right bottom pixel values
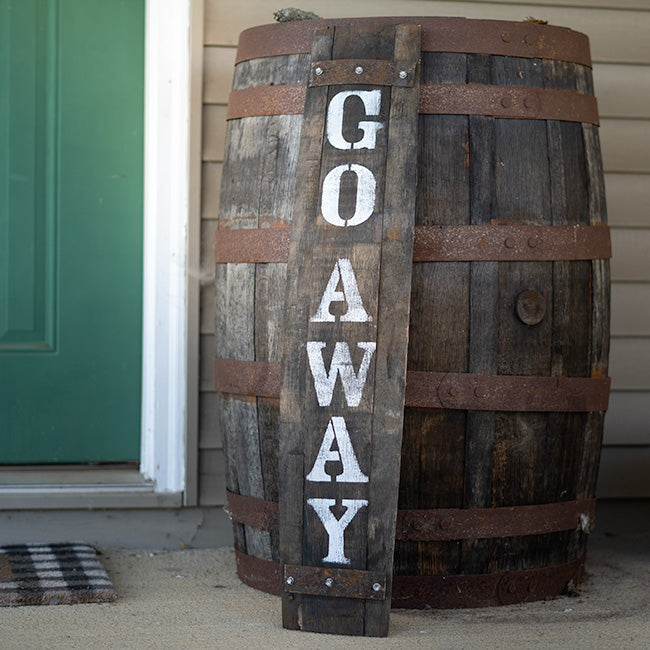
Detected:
left=236, top=16, right=591, bottom=66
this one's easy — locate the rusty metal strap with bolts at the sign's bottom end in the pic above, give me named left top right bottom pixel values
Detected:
left=283, top=564, right=386, bottom=600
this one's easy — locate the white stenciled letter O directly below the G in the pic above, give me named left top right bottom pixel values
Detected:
left=321, top=164, right=377, bottom=227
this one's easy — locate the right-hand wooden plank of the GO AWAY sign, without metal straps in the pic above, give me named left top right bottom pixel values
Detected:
left=366, top=25, right=420, bottom=636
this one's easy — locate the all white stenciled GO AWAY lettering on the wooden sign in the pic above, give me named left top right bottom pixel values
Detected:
left=305, top=89, right=384, bottom=564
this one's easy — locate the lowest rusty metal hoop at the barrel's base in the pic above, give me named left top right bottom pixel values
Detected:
left=235, top=549, right=585, bottom=609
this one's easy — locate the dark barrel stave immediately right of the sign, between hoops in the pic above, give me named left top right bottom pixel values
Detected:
left=396, top=49, right=470, bottom=574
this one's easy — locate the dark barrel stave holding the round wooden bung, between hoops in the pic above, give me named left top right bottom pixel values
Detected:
left=491, top=54, right=553, bottom=570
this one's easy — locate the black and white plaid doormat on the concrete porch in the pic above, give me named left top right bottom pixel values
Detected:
left=0, top=543, right=117, bottom=607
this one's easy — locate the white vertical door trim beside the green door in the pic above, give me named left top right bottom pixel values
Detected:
left=140, top=0, right=194, bottom=492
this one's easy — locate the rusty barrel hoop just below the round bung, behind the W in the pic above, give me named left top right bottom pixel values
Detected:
left=214, top=359, right=610, bottom=412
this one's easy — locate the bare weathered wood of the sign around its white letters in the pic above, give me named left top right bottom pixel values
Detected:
left=280, top=24, right=420, bottom=636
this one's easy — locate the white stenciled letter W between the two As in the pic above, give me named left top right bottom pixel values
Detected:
left=307, top=341, right=377, bottom=407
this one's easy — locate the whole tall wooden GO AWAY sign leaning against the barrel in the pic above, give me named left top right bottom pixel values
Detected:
left=280, top=24, right=420, bottom=636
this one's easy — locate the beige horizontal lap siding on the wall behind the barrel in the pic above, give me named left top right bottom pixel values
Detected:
left=199, top=0, right=650, bottom=505
